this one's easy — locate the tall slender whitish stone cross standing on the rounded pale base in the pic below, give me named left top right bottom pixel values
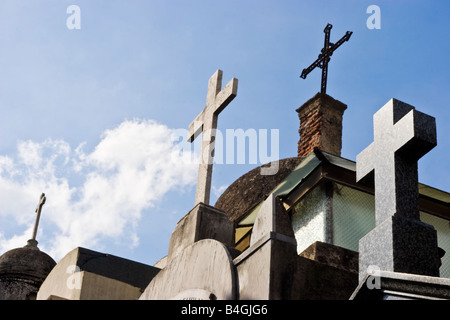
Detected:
left=188, top=70, right=238, bottom=204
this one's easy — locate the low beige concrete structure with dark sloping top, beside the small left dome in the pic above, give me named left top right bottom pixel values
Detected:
left=37, top=248, right=160, bottom=300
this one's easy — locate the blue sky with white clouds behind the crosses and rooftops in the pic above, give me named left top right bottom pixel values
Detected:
left=0, top=0, right=450, bottom=264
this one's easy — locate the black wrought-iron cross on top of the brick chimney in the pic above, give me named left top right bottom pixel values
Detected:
left=300, top=24, right=353, bottom=94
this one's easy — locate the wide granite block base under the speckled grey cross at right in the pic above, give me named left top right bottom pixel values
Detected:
left=359, top=215, right=439, bottom=280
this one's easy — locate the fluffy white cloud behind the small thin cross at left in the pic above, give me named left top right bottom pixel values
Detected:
left=0, top=120, right=197, bottom=259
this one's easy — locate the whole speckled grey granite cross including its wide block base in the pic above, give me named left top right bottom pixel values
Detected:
left=356, top=99, right=439, bottom=281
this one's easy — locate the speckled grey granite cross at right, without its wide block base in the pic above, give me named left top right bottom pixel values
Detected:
left=356, top=99, right=436, bottom=224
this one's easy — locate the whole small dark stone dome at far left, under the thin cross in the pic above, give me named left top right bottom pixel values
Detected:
left=0, top=244, right=56, bottom=300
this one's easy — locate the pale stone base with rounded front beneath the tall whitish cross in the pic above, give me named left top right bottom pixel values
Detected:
left=139, top=202, right=237, bottom=300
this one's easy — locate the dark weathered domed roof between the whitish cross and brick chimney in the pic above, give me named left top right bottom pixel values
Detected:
left=214, top=157, right=303, bottom=221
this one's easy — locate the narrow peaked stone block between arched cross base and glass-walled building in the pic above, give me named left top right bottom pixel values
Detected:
left=233, top=194, right=298, bottom=300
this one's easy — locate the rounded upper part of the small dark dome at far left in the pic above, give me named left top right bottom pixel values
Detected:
left=0, top=241, right=56, bottom=282
